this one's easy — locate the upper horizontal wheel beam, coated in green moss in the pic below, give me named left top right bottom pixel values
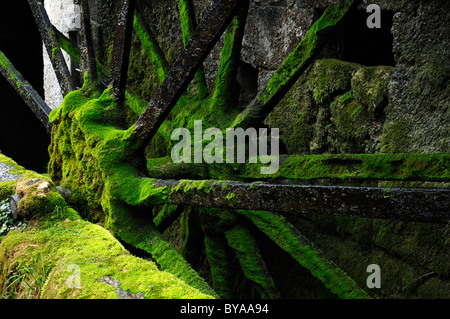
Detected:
left=147, top=153, right=450, bottom=183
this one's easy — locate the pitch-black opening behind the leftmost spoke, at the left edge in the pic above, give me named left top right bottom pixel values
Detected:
left=0, top=0, right=50, bottom=173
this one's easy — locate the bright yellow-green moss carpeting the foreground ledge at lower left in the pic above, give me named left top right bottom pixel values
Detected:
left=0, top=211, right=209, bottom=299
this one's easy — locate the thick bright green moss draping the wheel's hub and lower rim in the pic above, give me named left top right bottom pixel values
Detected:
left=49, top=84, right=216, bottom=294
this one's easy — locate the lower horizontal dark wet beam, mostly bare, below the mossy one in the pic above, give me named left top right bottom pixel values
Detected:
left=153, top=180, right=450, bottom=224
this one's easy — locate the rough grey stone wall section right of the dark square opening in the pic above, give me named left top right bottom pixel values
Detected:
left=381, top=0, right=450, bottom=153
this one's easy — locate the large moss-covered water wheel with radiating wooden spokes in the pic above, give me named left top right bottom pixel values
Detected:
left=1, top=0, right=449, bottom=298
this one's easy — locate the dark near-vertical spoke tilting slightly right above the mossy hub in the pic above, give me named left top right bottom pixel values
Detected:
left=111, top=0, right=135, bottom=105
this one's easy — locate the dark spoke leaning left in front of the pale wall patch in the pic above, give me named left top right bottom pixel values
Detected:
left=28, top=0, right=75, bottom=96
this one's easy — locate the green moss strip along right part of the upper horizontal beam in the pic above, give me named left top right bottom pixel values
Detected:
left=240, top=154, right=450, bottom=182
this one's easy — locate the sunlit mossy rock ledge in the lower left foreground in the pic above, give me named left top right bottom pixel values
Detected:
left=0, top=160, right=213, bottom=299
